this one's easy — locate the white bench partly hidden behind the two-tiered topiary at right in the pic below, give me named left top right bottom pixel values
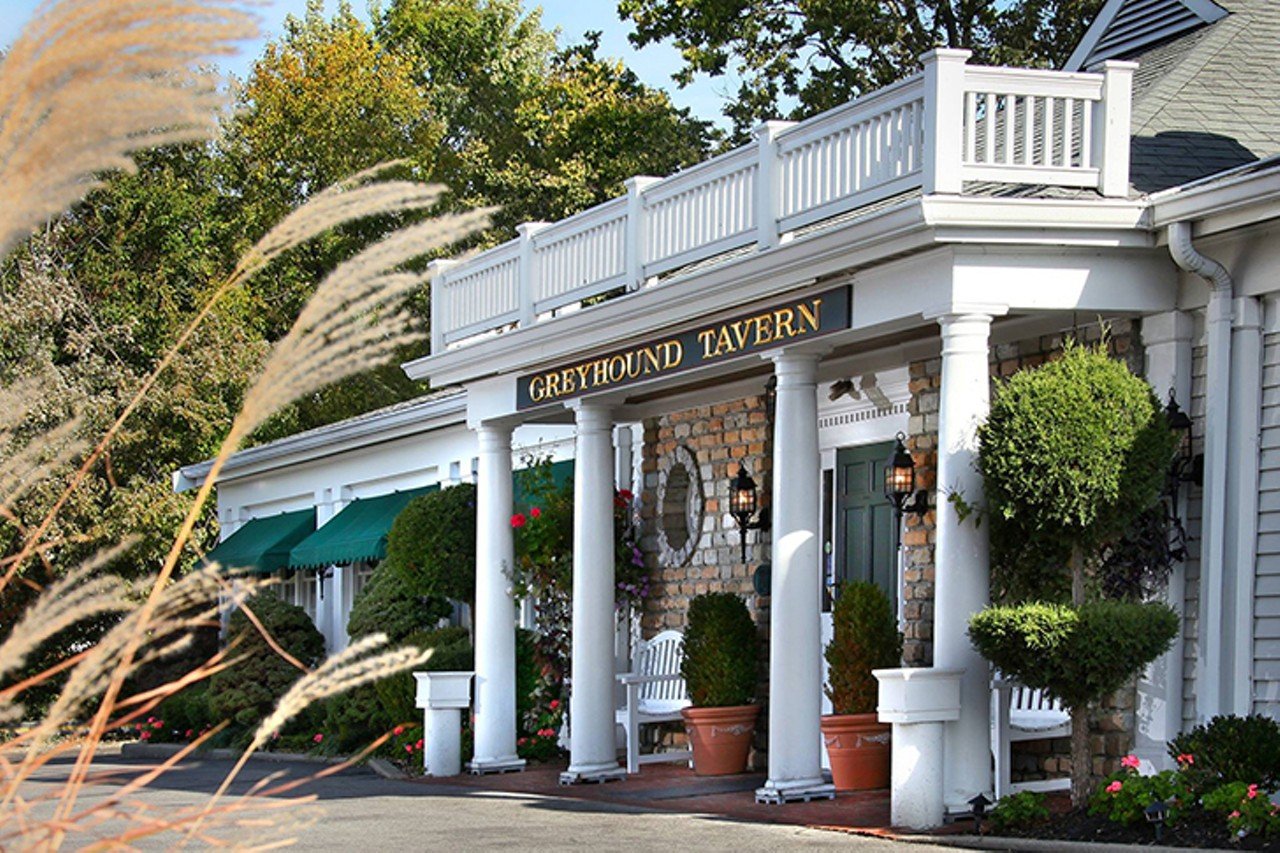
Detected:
left=991, top=672, right=1071, bottom=799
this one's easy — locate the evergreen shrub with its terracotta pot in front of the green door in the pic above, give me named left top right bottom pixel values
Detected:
left=822, top=581, right=902, bottom=790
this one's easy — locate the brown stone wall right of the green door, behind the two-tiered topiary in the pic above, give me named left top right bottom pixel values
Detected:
left=902, top=320, right=1143, bottom=780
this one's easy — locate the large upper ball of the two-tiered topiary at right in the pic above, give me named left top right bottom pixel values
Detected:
left=978, top=341, right=1175, bottom=603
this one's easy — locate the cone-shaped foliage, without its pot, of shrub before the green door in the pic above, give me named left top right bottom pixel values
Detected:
left=827, top=580, right=902, bottom=713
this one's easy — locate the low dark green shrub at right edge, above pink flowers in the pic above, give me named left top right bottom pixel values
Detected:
left=1169, top=715, right=1280, bottom=794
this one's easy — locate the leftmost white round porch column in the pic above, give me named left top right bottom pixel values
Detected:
left=467, top=424, right=525, bottom=774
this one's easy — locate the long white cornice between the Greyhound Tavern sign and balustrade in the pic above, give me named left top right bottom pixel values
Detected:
left=402, top=199, right=933, bottom=386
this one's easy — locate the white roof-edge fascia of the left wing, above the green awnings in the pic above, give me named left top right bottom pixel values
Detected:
left=173, top=391, right=467, bottom=492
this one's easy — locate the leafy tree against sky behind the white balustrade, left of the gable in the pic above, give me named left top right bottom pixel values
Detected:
left=618, top=0, right=1102, bottom=138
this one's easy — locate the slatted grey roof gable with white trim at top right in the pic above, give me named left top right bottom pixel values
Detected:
left=1065, top=0, right=1228, bottom=70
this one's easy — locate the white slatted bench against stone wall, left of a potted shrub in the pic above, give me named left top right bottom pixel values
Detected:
left=617, top=631, right=692, bottom=774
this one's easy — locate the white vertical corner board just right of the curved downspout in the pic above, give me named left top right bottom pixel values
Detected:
left=1222, top=296, right=1262, bottom=716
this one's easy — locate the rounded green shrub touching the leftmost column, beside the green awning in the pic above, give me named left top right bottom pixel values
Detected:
left=385, top=483, right=476, bottom=602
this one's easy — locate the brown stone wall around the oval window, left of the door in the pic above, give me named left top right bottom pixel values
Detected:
left=639, top=394, right=773, bottom=766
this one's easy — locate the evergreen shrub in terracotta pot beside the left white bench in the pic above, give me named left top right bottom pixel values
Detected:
left=680, top=593, right=760, bottom=776
